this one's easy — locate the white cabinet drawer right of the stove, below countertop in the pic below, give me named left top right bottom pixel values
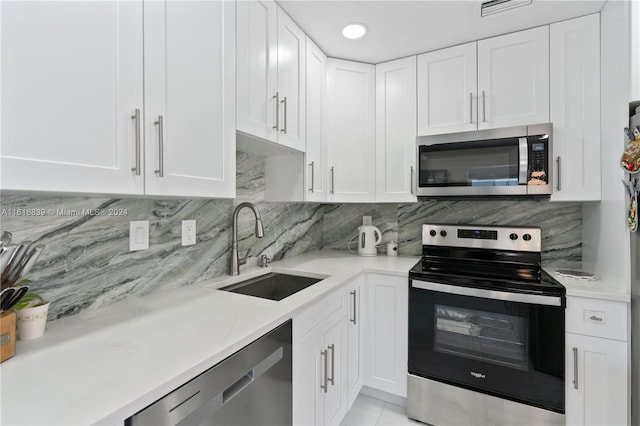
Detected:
left=566, top=297, right=627, bottom=341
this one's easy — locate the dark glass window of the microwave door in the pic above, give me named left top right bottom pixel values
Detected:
left=419, top=138, right=519, bottom=187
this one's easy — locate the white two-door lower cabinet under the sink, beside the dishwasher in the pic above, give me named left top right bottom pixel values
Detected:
left=293, top=291, right=348, bottom=425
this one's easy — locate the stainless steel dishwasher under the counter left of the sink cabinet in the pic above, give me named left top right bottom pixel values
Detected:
left=125, top=320, right=293, bottom=426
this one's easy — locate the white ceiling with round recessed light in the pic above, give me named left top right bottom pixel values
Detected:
left=278, top=0, right=606, bottom=64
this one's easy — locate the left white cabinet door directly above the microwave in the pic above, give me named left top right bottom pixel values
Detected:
left=418, top=42, right=478, bottom=136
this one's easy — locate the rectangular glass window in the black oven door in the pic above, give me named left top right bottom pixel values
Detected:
left=434, top=305, right=529, bottom=371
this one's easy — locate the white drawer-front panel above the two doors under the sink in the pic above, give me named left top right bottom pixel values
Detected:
left=293, top=290, right=348, bottom=341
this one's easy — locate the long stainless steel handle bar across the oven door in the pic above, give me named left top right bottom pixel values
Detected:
left=411, top=280, right=562, bottom=306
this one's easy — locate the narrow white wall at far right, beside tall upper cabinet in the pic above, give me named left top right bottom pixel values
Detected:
left=582, top=1, right=630, bottom=288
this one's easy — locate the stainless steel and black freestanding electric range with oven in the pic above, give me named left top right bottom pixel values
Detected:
left=407, top=225, right=566, bottom=425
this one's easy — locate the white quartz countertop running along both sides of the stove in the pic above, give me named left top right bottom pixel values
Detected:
left=0, top=251, right=629, bottom=425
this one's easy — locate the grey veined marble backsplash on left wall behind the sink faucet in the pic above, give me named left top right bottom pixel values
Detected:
left=0, top=152, right=324, bottom=320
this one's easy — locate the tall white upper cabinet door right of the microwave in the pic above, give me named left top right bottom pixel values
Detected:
left=550, top=14, right=601, bottom=201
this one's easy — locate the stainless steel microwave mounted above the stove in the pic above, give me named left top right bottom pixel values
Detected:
left=416, top=123, right=553, bottom=197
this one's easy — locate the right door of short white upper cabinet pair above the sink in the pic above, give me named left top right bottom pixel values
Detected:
left=278, top=8, right=306, bottom=151
